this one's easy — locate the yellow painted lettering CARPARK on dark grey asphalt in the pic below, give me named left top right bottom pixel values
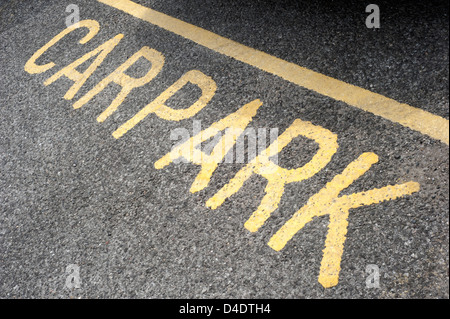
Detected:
left=25, top=16, right=426, bottom=287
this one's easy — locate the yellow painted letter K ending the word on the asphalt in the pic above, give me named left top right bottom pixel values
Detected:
left=268, top=153, right=420, bottom=288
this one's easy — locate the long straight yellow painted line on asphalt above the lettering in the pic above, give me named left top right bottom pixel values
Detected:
left=98, top=0, right=449, bottom=145
